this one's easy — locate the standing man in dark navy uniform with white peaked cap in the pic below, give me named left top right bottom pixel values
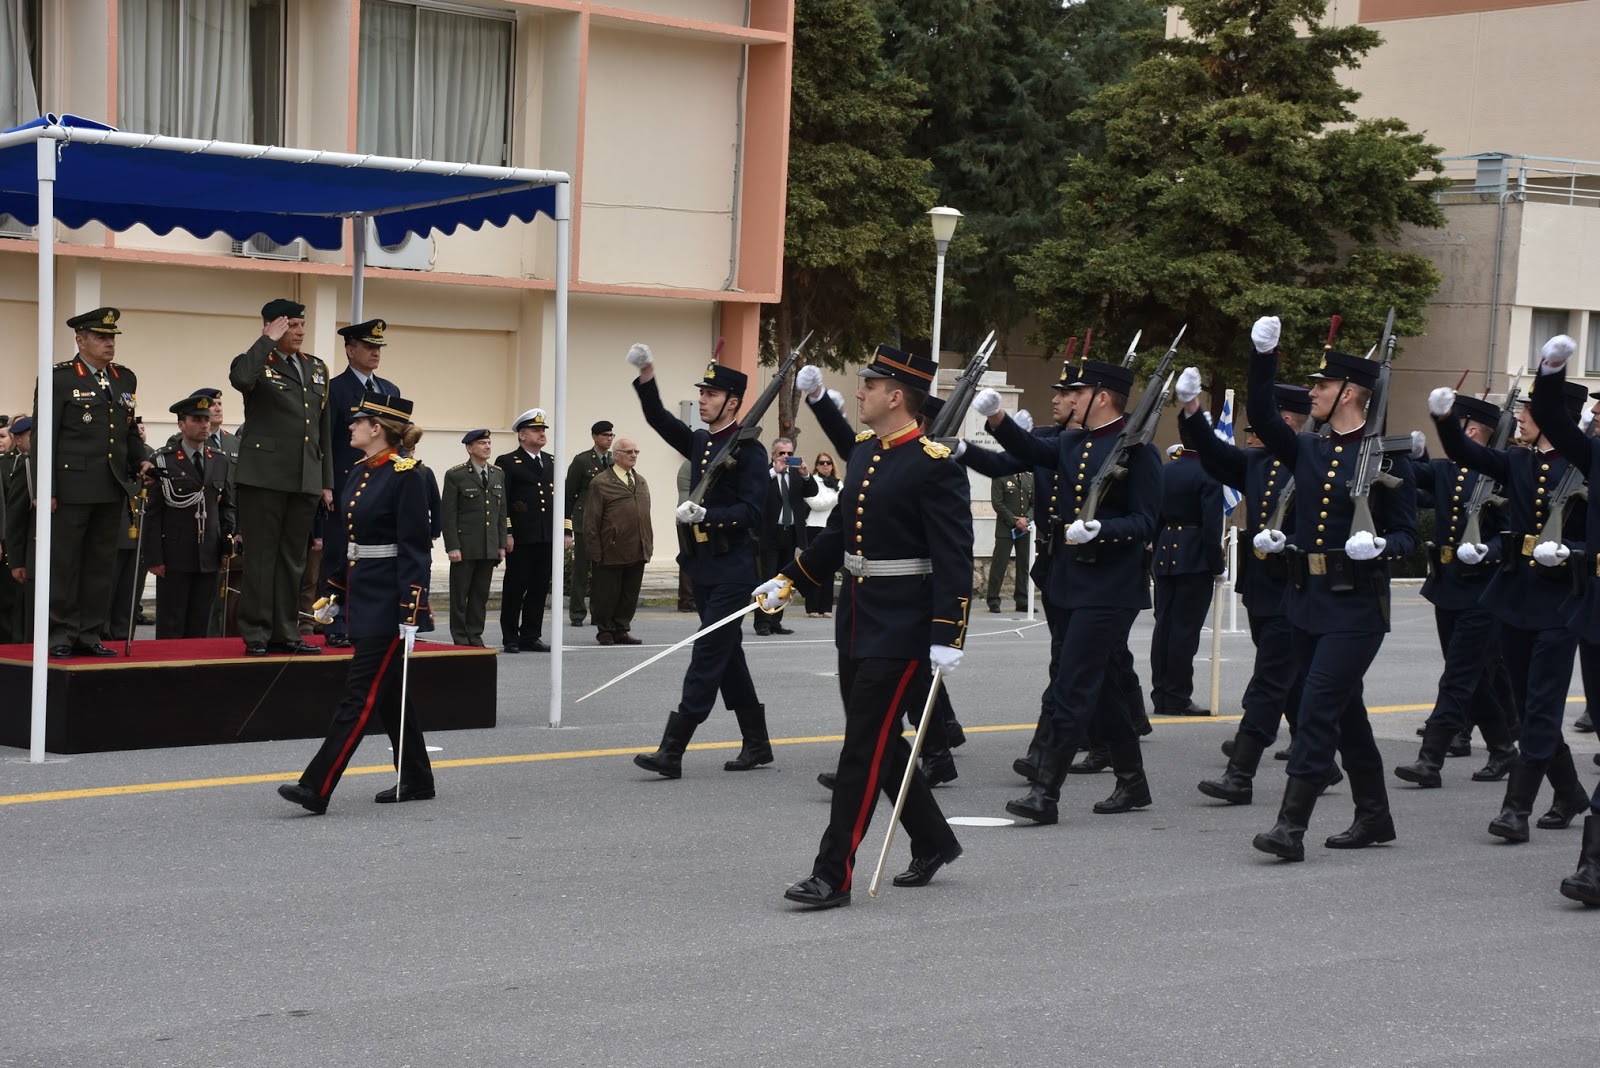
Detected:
left=440, top=428, right=510, bottom=648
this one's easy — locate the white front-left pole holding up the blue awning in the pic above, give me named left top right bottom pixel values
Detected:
left=27, top=137, right=56, bottom=764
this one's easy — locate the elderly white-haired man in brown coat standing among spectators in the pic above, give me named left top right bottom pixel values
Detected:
left=584, top=438, right=654, bottom=646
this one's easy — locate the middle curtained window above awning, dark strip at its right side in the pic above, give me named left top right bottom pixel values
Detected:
left=117, top=0, right=285, bottom=144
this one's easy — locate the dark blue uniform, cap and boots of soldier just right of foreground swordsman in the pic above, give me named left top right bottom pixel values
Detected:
left=994, top=360, right=1162, bottom=823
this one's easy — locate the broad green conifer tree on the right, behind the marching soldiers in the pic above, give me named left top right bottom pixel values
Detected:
left=1018, top=0, right=1443, bottom=393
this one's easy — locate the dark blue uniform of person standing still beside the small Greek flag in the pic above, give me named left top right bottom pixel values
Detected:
left=1150, top=449, right=1222, bottom=716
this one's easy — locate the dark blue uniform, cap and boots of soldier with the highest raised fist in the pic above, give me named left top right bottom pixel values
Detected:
left=1246, top=342, right=1416, bottom=860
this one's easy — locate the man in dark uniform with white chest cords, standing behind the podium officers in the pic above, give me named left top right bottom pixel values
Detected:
left=144, top=393, right=237, bottom=638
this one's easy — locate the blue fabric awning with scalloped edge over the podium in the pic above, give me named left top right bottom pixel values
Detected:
left=0, top=115, right=565, bottom=249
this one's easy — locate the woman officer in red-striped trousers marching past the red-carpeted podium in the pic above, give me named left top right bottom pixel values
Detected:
left=278, top=393, right=434, bottom=815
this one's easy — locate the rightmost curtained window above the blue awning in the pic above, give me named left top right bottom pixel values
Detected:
left=355, top=0, right=517, bottom=166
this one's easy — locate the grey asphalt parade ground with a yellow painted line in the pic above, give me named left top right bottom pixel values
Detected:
left=0, top=588, right=1600, bottom=1068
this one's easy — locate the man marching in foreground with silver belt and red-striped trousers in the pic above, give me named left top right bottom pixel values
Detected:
left=757, top=345, right=973, bottom=908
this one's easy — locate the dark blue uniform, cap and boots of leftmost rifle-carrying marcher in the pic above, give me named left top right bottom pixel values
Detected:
left=634, top=363, right=773, bottom=779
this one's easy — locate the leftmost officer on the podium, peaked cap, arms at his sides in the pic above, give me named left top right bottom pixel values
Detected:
left=34, top=309, right=150, bottom=657
